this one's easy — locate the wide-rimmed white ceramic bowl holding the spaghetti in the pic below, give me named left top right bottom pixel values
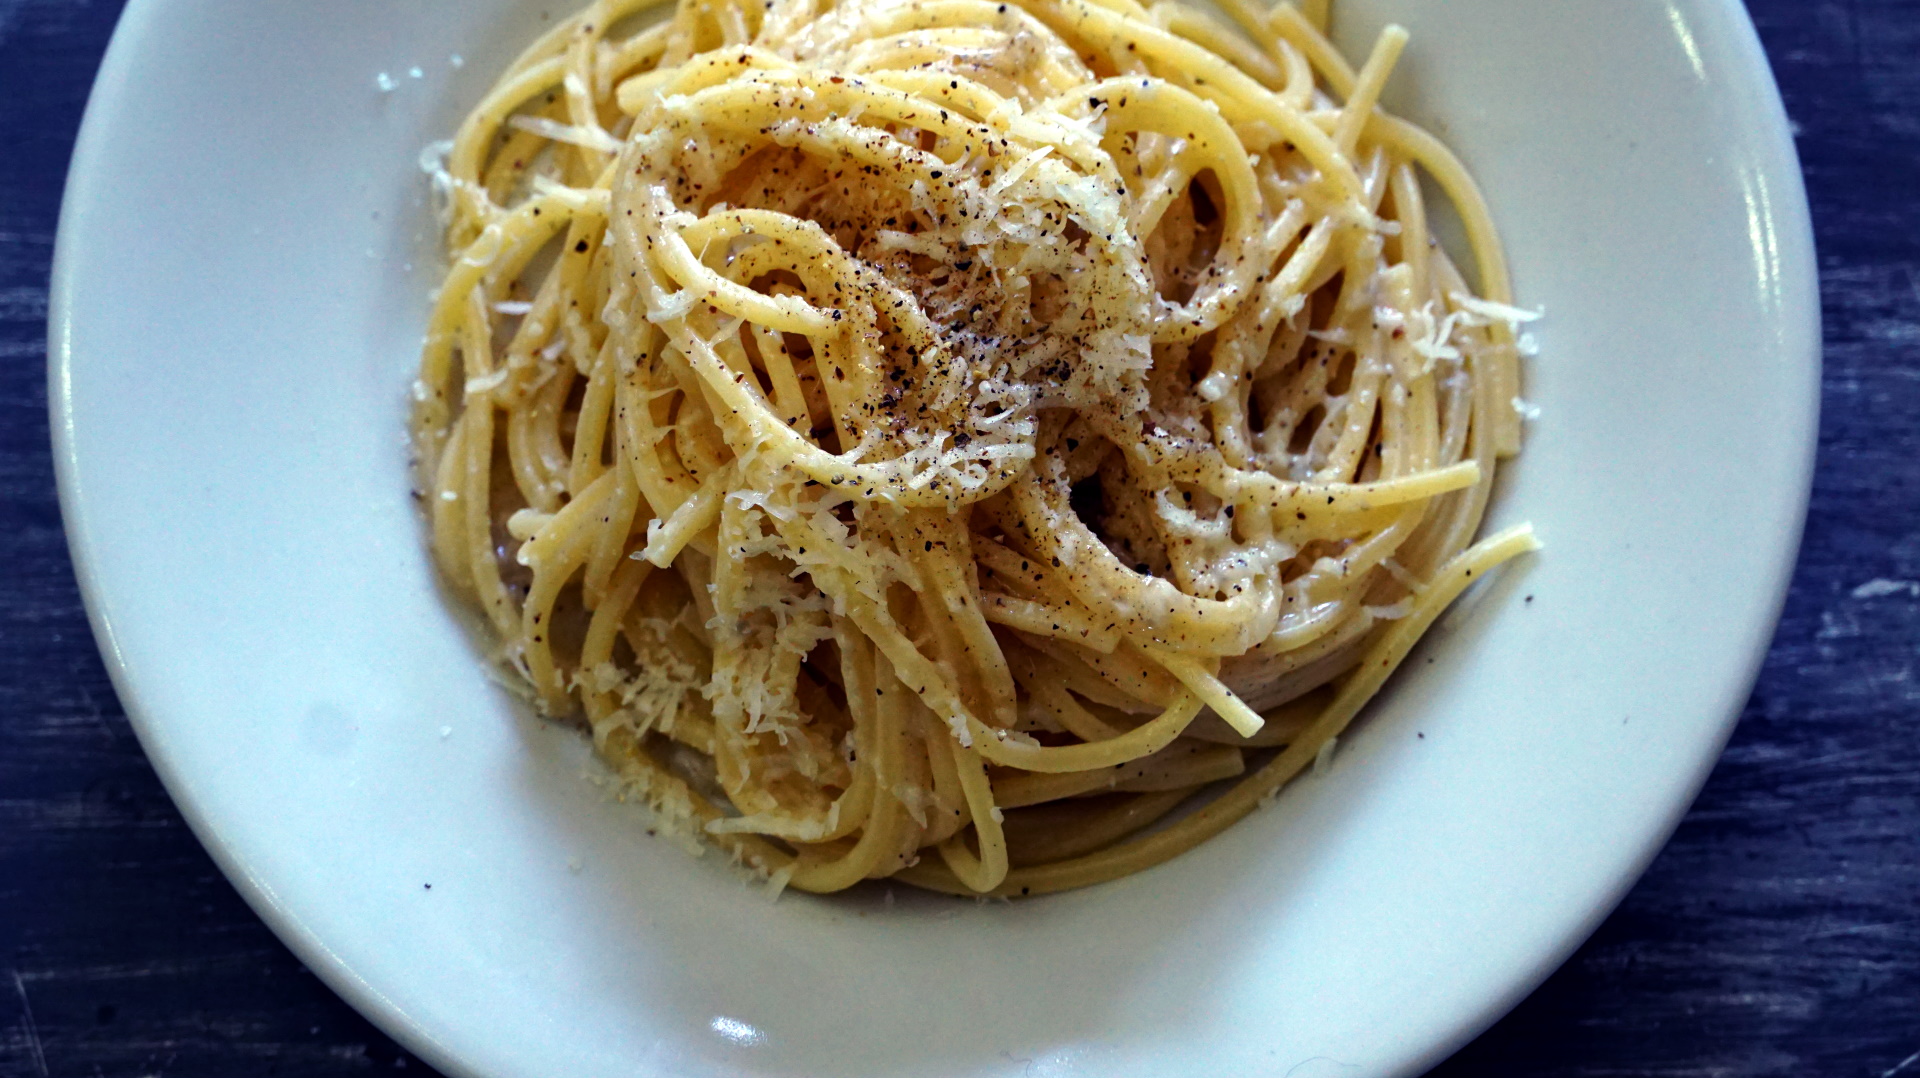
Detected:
left=52, top=0, right=1818, bottom=1072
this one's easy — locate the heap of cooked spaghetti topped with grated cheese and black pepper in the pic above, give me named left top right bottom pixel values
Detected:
left=413, top=0, right=1534, bottom=896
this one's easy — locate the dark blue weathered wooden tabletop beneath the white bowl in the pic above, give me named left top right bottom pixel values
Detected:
left=0, top=0, right=1920, bottom=1076
